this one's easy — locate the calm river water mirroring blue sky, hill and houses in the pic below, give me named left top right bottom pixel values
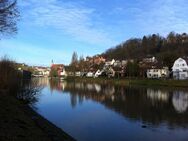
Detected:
left=32, top=79, right=188, bottom=141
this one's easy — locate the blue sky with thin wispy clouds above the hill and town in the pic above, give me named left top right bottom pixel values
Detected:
left=0, top=0, right=188, bottom=65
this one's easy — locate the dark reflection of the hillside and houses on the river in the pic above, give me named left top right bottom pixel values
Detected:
left=40, top=80, right=188, bottom=127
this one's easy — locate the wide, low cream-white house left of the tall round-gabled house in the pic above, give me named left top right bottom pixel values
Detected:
left=147, top=67, right=170, bottom=78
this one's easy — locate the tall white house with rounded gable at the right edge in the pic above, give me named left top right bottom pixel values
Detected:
left=172, top=58, right=188, bottom=80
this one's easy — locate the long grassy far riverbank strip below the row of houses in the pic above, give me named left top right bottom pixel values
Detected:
left=67, top=77, right=188, bottom=88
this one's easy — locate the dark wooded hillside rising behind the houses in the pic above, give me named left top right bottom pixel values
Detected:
left=102, top=32, right=188, bottom=67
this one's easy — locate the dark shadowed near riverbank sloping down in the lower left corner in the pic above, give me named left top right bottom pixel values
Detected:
left=0, top=91, right=74, bottom=141
